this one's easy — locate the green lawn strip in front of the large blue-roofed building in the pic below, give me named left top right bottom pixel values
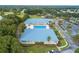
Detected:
left=25, top=44, right=57, bottom=53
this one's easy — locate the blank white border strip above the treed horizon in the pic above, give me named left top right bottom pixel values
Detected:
left=0, top=0, right=79, bottom=5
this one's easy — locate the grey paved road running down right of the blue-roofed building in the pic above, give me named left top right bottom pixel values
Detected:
left=56, top=21, right=78, bottom=53
